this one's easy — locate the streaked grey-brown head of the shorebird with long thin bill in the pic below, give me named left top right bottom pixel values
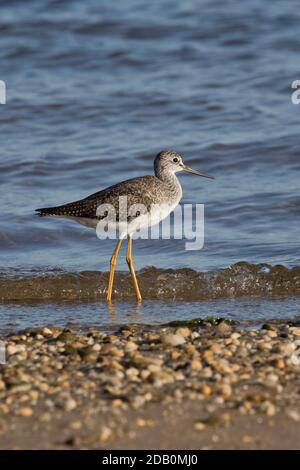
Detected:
left=154, top=150, right=214, bottom=179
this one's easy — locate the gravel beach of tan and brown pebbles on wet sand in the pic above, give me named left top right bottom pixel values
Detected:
left=0, top=319, right=300, bottom=449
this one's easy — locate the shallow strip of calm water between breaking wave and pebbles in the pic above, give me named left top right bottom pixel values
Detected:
left=0, top=297, right=299, bottom=331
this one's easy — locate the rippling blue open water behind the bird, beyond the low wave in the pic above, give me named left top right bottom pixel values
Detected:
left=0, top=0, right=300, bottom=330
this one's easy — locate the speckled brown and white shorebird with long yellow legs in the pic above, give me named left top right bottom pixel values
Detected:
left=36, top=150, right=213, bottom=302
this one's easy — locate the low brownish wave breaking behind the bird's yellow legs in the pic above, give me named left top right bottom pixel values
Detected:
left=0, top=262, right=300, bottom=303
